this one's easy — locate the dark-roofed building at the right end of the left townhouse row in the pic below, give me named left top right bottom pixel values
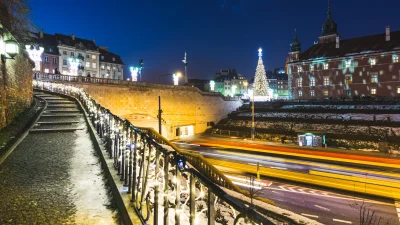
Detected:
left=99, top=46, right=123, bottom=81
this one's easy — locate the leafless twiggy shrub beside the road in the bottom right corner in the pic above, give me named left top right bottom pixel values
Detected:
left=350, top=200, right=390, bottom=225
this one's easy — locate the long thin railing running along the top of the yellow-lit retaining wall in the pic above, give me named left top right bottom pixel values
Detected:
left=33, top=72, right=240, bottom=101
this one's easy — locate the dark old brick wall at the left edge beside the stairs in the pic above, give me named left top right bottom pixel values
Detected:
left=0, top=53, right=32, bottom=129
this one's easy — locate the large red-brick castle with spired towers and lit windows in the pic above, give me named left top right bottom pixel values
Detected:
left=288, top=2, right=400, bottom=99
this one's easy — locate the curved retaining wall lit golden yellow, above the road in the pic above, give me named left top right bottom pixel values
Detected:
left=67, top=83, right=242, bottom=139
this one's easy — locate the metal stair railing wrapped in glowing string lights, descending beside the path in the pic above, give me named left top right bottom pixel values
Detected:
left=34, top=81, right=312, bottom=225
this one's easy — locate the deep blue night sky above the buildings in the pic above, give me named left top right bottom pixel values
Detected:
left=31, top=0, right=400, bottom=81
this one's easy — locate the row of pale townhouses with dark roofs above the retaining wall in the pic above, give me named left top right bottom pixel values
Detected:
left=26, top=31, right=124, bottom=79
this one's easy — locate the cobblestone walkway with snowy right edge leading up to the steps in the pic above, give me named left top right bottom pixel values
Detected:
left=0, top=92, right=118, bottom=225
